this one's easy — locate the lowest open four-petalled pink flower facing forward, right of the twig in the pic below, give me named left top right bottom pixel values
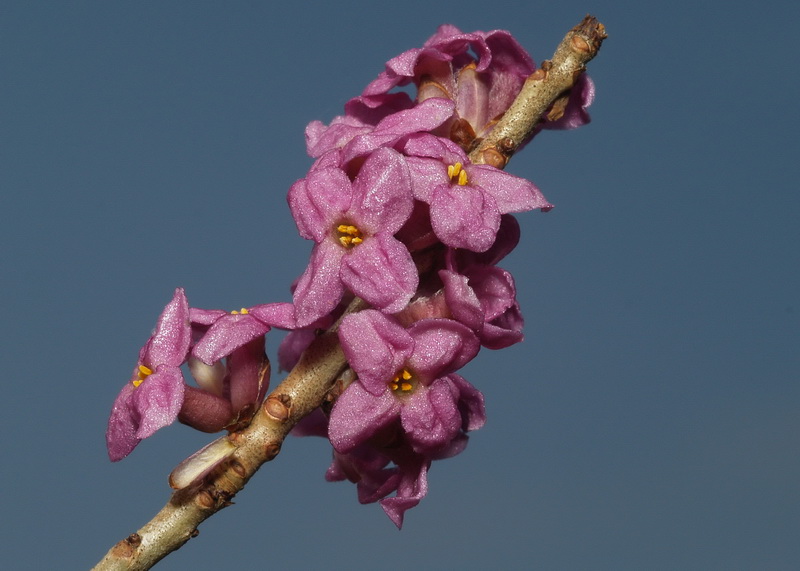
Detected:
left=328, top=310, right=485, bottom=453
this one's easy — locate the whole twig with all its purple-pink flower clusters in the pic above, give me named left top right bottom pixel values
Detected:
left=96, top=16, right=605, bottom=569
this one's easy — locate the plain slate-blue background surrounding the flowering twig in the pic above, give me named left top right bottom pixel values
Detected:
left=0, top=0, right=800, bottom=570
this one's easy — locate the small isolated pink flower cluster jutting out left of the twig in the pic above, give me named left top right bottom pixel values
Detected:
left=106, top=288, right=270, bottom=461
